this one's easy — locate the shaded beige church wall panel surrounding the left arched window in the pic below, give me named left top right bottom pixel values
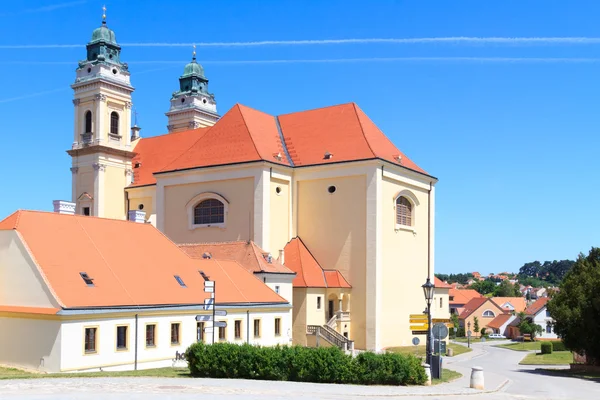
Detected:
left=164, top=178, right=254, bottom=243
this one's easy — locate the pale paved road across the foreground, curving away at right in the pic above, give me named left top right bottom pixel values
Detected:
left=0, top=343, right=600, bottom=400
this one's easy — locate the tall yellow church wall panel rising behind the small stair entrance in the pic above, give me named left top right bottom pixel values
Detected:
left=296, top=176, right=367, bottom=349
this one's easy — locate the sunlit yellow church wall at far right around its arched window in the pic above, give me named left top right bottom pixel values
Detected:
left=380, top=178, right=433, bottom=348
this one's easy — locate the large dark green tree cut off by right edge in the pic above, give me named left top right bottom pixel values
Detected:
left=548, top=247, right=600, bottom=365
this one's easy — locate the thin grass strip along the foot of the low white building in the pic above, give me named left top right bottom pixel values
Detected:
left=0, top=367, right=190, bottom=379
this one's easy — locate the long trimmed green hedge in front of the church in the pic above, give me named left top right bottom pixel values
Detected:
left=185, top=343, right=427, bottom=385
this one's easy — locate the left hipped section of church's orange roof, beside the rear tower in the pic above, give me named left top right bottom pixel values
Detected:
left=156, top=104, right=290, bottom=172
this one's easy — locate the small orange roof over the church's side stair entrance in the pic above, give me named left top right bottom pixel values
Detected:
left=284, top=237, right=351, bottom=288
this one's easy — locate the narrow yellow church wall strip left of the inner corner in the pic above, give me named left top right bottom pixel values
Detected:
left=270, top=178, right=291, bottom=257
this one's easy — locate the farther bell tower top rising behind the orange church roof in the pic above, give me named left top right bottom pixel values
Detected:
left=166, top=46, right=219, bottom=133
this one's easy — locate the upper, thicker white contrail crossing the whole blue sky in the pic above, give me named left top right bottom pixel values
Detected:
left=5, top=36, right=600, bottom=49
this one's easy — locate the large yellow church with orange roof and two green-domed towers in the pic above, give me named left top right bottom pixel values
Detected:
left=65, top=13, right=441, bottom=350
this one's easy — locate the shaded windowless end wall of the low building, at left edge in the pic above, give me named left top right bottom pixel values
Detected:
left=0, top=317, right=61, bottom=372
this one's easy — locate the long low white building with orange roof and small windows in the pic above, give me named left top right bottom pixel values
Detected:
left=0, top=211, right=292, bottom=372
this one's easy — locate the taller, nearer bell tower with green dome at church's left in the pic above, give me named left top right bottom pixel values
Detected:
left=67, top=8, right=134, bottom=219
